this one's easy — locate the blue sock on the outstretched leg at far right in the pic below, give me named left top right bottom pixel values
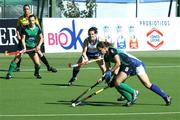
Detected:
left=150, top=84, right=167, bottom=99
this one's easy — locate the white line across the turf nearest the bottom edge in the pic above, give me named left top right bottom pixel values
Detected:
left=0, top=112, right=180, bottom=117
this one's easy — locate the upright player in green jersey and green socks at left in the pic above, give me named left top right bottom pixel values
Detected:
left=6, top=15, right=43, bottom=79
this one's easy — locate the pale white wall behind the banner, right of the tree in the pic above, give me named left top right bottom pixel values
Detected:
left=97, top=2, right=176, bottom=18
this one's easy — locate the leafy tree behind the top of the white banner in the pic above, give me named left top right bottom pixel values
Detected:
left=58, top=0, right=97, bottom=18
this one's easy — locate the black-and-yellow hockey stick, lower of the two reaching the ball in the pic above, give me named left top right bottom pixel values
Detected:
left=72, top=86, right=109, bottom=107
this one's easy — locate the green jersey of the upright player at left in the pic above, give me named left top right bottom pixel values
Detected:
left=22, top=25, right=42, bottom=49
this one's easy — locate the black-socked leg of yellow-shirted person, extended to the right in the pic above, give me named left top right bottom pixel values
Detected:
left=38, top=50, right=57, bottom=72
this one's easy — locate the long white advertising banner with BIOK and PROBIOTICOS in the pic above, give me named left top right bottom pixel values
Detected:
left=43, top=18, right=180, bottom=53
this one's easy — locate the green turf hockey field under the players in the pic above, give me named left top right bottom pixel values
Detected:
left=0, top=51, right=180, bottom=120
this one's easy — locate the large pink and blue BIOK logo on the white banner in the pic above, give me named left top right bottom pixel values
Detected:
left=48, top=20, right=83, bottom=49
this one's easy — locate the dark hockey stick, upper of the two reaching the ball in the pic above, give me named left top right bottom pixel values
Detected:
left=72, top=75, right=104, bottom=103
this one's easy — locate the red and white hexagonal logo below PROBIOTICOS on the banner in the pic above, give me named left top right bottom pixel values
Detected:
left=146, top=28, right=164, bottom=50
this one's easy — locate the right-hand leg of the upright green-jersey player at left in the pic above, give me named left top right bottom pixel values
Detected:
left=29, top=52, right=42, bottom=79
